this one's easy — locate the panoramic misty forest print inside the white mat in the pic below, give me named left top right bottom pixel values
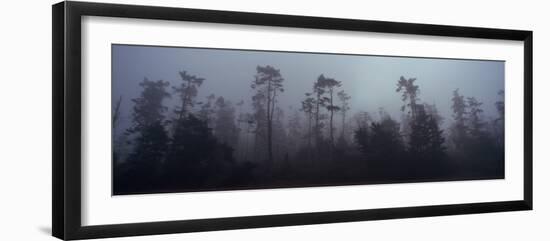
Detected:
left=111, top=44, right=505, bottom=195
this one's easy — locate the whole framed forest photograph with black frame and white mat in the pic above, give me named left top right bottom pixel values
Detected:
left=52, top=1, right=533, bottom=239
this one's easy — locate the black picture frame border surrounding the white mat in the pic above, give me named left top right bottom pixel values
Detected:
left=52, top=2, right=533, bottom=240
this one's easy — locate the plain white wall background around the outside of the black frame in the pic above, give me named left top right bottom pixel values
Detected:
left=0, top=0, right=550, bottom=241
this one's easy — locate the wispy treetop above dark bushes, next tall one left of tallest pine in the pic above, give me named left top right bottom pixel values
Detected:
left=172, top=71, right=204, bottom=119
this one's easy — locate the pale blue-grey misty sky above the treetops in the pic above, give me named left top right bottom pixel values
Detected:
left=112, top=45, right=505, bottom=133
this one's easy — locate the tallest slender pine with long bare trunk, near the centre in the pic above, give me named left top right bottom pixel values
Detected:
left=251, top=65, right=284, bottom=164
